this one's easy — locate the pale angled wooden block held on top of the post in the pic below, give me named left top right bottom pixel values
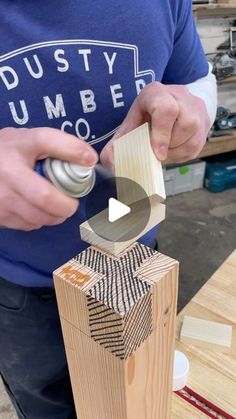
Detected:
left=80, top=124, right=165, bottom=256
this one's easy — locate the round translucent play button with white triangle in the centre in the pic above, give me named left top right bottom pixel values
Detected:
left=85, top=177, right=151, bottom=243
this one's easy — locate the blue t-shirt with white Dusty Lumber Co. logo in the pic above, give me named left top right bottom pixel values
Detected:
left=0, top=0, right=208, bottom=286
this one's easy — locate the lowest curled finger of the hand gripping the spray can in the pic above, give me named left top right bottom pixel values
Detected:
left=14, top=195, right=66, bottom=226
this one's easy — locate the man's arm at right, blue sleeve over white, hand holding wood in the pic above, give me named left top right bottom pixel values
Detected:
left=101, top=0, right=217, bottom=166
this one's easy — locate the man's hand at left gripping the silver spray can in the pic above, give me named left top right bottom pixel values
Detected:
left=0, top=128, right=97, bottom=231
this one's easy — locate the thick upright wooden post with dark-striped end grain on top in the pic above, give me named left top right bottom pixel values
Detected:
left=54, top=243, right=178, bottom=419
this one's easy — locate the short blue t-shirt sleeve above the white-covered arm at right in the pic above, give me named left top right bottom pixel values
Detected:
left=162, top=0, right=208, bottom=84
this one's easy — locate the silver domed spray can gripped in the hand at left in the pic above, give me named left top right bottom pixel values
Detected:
left=35, top=157, right=96, bottom=198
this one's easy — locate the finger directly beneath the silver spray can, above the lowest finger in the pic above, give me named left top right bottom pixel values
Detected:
left=8, top=166, right=79, bottom=218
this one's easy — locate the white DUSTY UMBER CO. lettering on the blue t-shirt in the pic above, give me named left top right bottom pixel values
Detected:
left=0, top=48, right=146, bottom=130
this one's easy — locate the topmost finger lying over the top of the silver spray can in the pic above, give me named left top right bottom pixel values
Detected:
left=24, top=127, right=98, bottom=166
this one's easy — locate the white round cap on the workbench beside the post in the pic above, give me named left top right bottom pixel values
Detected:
left=173, top=351, right=189, bottom=391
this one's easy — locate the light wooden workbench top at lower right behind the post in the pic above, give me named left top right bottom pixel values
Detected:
left=171, top=250, right=236, bottom=419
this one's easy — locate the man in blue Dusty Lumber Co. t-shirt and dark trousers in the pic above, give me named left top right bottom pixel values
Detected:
left=0, top=0, right=216, bottom=419
